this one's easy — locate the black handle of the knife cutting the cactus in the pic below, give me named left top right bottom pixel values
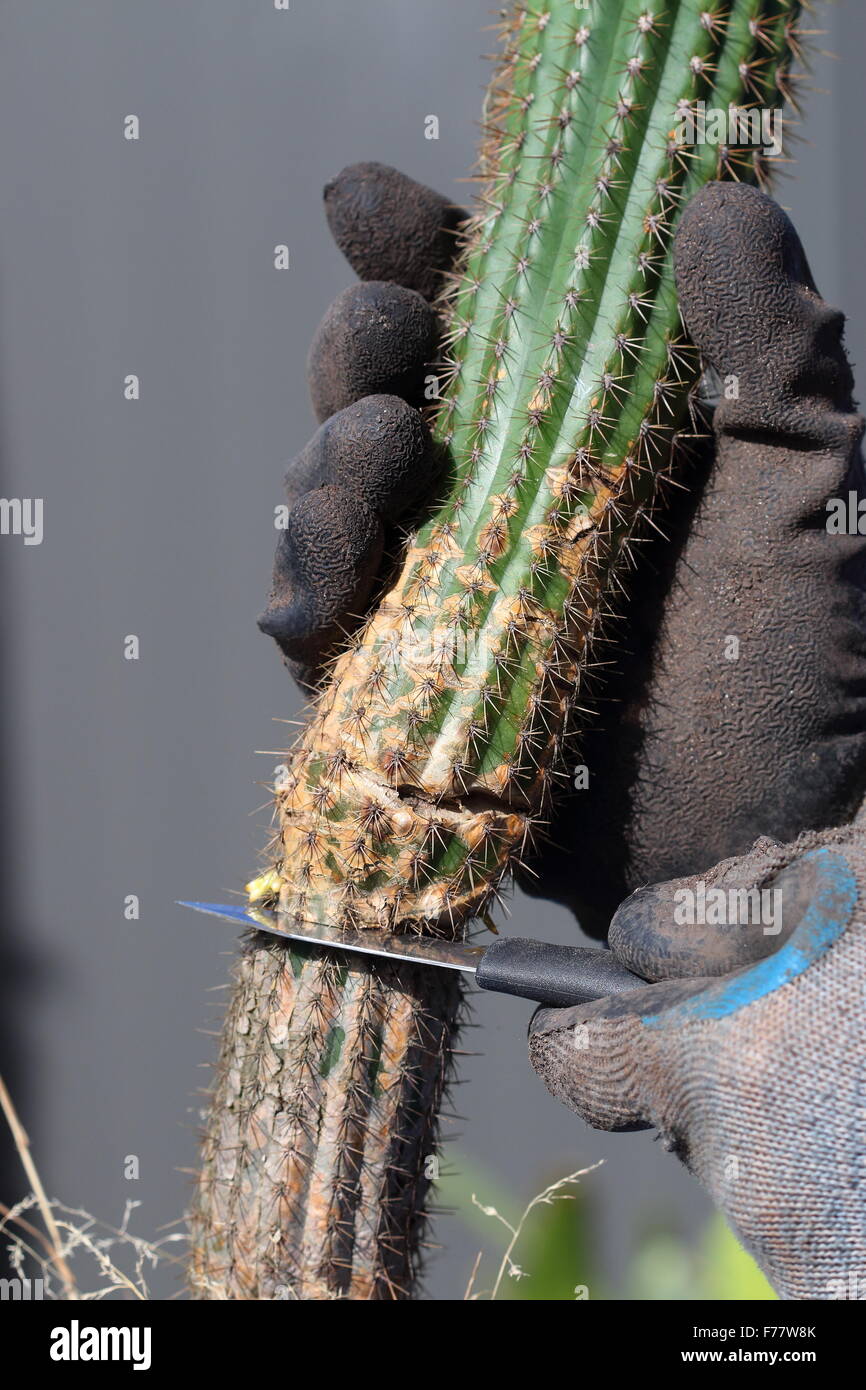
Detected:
left=475, top=937, right=646, bottom=1008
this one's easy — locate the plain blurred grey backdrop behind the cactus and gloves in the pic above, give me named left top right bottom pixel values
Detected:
left=0, top=0, right=866, bottom=1298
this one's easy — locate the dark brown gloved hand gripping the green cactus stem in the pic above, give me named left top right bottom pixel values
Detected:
left=260, top=164, right=866, bottom=937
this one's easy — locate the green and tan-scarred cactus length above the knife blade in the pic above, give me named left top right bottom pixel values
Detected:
left=277, top=0, right=796, bottom=927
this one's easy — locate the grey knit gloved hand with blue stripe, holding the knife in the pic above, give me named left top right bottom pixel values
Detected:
left=530, top=824, right=866, bottom=1300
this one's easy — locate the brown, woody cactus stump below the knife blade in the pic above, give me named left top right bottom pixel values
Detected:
left=190, top=944, right=460, bottom=1300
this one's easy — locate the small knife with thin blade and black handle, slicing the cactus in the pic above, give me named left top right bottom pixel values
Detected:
left=178, top=902, right=646, bottom=1008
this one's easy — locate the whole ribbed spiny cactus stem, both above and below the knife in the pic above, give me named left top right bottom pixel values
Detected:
left=193, top=0, right=801, bottom=1298
